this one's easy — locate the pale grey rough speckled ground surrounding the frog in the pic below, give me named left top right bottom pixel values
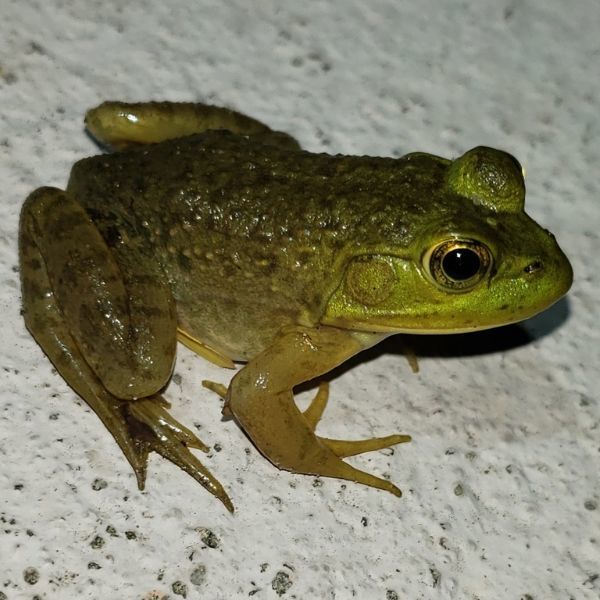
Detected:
left=0, top=0, right=600, bottom=600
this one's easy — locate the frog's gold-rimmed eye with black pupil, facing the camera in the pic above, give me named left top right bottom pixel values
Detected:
left=425, top=240, right=492, bottom=292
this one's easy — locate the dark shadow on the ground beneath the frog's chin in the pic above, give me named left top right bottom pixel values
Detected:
left=295, top=298, right=570, bottom=392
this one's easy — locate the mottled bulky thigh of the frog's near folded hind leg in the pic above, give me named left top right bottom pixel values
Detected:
left=22, top=188, right=176, bottom=399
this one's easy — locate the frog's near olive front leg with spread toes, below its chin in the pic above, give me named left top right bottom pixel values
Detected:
left=227, top=327, right=410, bottom=496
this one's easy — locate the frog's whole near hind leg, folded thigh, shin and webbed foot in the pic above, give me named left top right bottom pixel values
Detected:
left=19, top=188, right=233, bottom=510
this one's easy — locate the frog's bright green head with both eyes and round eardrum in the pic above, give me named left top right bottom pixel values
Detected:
left=324, top=147, right=573, bottom=333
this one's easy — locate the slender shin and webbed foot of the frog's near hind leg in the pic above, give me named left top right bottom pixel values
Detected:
left=19, top=188, right=233, bottom=510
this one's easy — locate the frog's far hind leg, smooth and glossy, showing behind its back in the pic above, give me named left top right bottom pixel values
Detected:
left=85, top=102, right=300, bottom=150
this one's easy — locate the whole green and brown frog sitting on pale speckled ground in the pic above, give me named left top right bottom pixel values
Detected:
left=19, top=101, right=573, bottom=511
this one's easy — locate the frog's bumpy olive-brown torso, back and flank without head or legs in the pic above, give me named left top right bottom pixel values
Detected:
left=68, top=131, right=445, bottom=358
